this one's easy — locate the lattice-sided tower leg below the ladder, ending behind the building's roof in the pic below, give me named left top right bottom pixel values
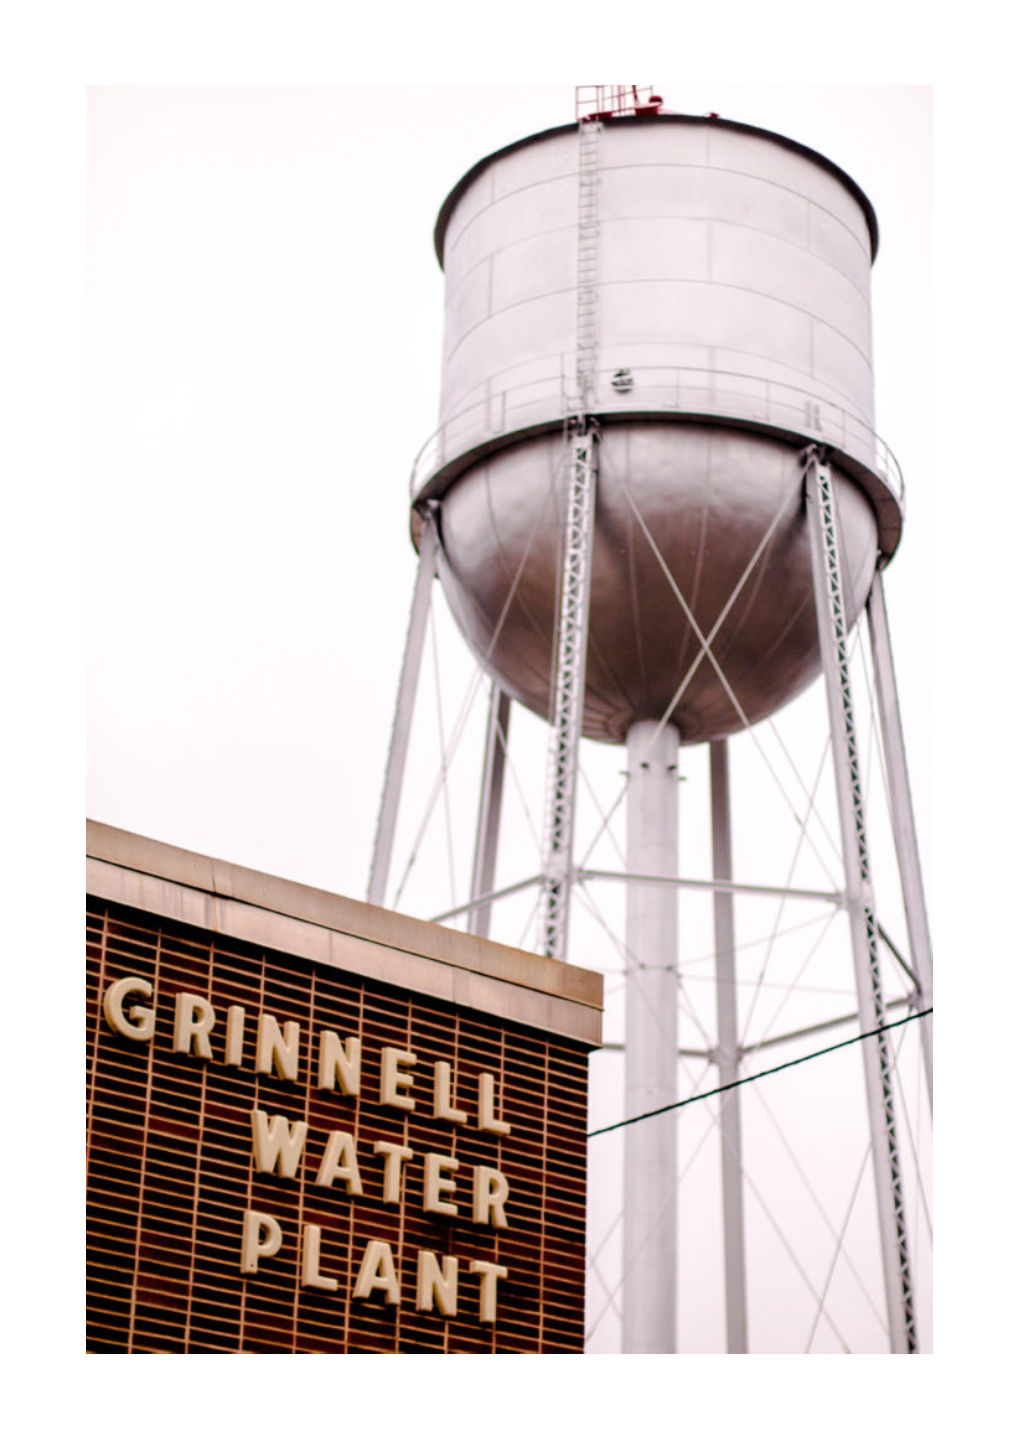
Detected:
left=535, top=424, right=599, bottom=960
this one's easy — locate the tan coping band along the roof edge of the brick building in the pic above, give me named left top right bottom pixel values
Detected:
left=85, top=820, right=603, bottom=1047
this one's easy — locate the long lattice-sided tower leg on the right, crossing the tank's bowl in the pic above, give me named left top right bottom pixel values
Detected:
left=805, top=446, right=918, bottom=1353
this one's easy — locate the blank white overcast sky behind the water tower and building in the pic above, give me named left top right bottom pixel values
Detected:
left=88, top=76, right=932, bottom=1350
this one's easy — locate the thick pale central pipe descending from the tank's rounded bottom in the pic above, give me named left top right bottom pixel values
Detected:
left=623, top=721, right=680, bottom=1353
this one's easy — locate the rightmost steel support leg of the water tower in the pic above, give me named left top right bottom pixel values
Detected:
left=867, top=571, right=933, bottom=1106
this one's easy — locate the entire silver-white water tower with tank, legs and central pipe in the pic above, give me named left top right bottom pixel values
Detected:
left=369, top=87, right=932, bottom=1353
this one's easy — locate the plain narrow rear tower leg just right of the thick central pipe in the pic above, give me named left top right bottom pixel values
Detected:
left=708, top=741, right=747, bottom=1353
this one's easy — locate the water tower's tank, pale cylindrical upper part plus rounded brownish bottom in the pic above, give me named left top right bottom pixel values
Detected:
left=413, top=114, right=902, bottom=744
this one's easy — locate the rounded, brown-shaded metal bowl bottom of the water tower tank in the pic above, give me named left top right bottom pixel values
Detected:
left=439, top=420, right=877, bottom=744
